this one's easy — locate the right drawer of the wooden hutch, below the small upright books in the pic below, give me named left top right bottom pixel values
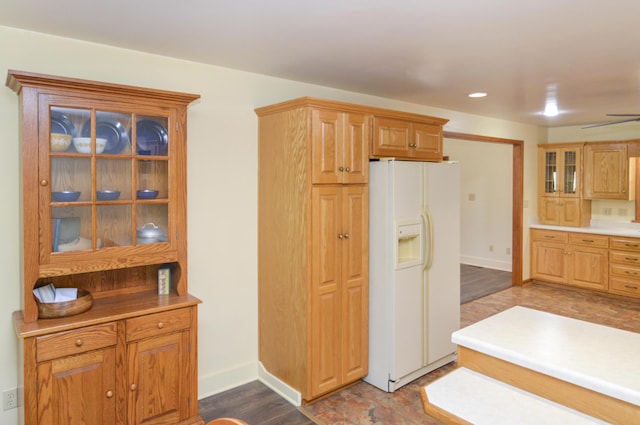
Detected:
left=126, top=308, right=191, bottom=341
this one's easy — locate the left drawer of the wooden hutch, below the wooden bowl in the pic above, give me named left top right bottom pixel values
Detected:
left=36, top=322, right=117, bottom=362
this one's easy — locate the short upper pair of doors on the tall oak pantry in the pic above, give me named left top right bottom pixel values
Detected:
left=311, top=108, right=370, bottom=184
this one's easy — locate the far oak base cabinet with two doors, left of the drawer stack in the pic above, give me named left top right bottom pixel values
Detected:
left=531, top=229, right=609, bottom=291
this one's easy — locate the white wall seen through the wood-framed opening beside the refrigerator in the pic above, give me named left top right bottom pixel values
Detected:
left=444, top=139, right=513, bottom=271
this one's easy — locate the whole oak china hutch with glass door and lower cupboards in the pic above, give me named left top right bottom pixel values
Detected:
left=7, top=71, right=202, bottom=425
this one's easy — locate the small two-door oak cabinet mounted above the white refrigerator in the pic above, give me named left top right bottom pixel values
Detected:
left=371, top=113, right=448, bottom=161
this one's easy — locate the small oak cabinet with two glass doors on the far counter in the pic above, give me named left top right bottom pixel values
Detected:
left=538, top=143, right=591, bottom=226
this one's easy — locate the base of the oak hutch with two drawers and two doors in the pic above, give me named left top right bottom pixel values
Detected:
left=14, top=306, right=204, bottom=425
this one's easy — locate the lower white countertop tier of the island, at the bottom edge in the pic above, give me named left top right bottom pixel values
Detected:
left=425, top=367, right=607, bottom=425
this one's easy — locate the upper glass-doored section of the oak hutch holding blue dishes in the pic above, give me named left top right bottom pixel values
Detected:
left=7, top=71, right=199, bottom=322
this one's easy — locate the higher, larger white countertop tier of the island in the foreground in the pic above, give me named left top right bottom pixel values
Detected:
left=451, top=306, right=640, bottom=406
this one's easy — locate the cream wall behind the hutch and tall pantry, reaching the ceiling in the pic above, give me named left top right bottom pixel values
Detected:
left=0, top=27, right=546, bottom=424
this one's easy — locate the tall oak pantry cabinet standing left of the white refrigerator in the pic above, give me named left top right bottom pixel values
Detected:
left=256, top=98, right=371, bottom=401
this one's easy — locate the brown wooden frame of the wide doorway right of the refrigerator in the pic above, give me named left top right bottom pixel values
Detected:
left=443, top=131, right=524, bottom=285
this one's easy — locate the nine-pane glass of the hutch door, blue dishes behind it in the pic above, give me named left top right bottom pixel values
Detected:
left=48, top=106, right=170, bottom=253
